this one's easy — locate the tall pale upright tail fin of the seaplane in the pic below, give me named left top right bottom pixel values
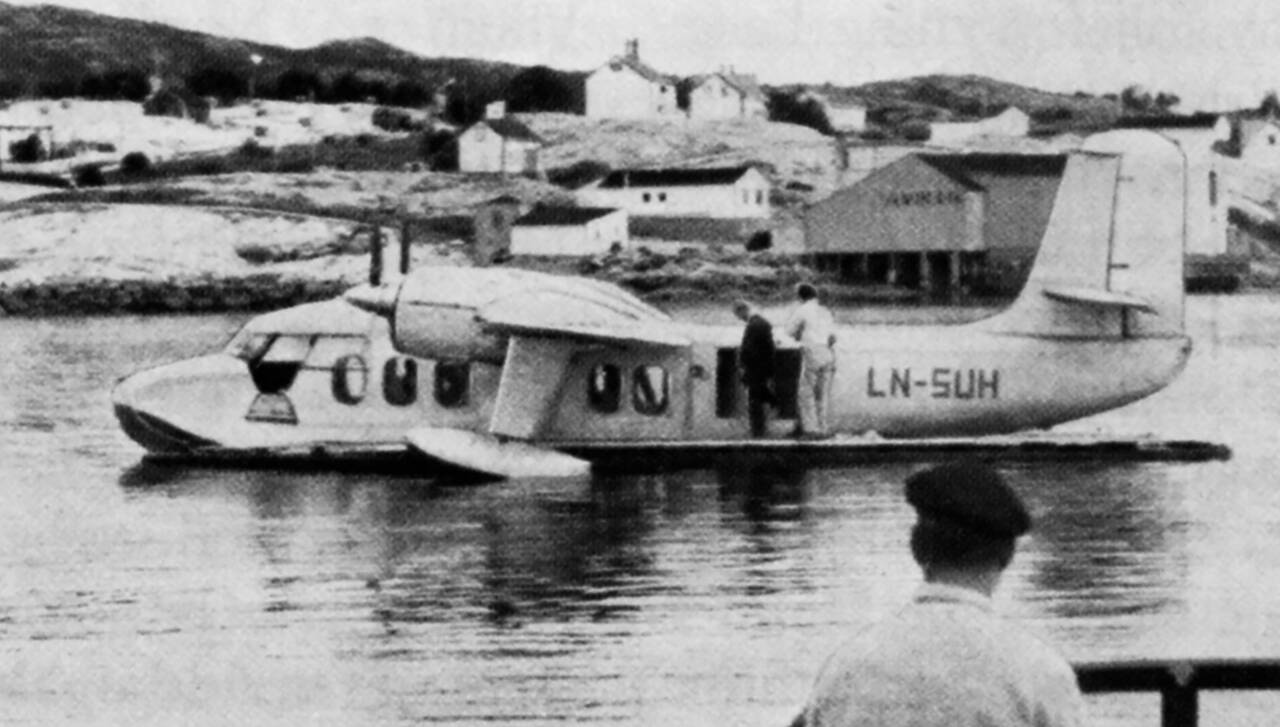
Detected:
left=988, top=131, right=1187, bottom=338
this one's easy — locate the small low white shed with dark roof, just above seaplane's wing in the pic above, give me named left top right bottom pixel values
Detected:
left=511, top=207, right=628, bottom=256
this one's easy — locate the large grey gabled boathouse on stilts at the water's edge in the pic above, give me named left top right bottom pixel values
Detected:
left=804, top=154, right=1066, bottom=289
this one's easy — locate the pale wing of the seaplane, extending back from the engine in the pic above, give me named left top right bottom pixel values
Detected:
left=476, top=291, right=690, bottom=347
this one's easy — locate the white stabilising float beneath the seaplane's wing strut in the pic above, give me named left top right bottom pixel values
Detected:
left=404, top=426, right=591, bottom=477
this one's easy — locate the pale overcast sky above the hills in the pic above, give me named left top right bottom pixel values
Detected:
left=8, top=0, right=1280, bottom=110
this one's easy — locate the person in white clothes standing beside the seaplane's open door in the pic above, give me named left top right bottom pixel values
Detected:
left=786, top=283, right=836, bottom=438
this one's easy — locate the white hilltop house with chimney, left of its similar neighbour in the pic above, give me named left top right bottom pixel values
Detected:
left=586, top=40, right=680, bottom=119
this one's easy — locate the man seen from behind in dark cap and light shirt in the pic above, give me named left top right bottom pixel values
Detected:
left=792, top=462, right=1084, bottom=727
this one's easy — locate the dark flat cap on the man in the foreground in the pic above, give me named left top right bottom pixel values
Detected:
left=906, top=459, right=1032, bottom=538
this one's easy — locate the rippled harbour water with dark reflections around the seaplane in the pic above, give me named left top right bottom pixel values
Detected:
left=0, top=297, right=1280, bottom=724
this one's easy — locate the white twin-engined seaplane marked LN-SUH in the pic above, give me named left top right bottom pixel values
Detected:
left=113, top=131, right=1218, bottom=477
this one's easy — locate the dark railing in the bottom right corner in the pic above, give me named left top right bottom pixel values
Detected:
left=1075, top=659, right=1280, bottom=727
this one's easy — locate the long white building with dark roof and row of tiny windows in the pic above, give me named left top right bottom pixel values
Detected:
left=579, top=166, right=772, bottom=219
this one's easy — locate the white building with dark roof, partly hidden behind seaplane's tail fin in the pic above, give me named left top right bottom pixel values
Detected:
left=1115, top=113, right=1231, bottom=256
